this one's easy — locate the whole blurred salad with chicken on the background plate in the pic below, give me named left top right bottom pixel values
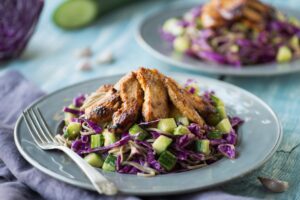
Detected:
left=160, top=0, right=300, bottom=67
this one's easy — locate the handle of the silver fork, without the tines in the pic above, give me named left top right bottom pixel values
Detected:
left=58, top=146, right=118, bottom=195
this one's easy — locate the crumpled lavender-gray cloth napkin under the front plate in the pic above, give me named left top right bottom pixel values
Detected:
left=0, top=71, right=252, bottom=200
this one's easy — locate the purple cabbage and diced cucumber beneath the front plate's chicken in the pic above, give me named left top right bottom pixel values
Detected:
left=56, top=80, right=243, bottom=176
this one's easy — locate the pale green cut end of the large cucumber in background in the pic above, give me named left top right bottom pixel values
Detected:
left=53, top=0, right=99, bottom=29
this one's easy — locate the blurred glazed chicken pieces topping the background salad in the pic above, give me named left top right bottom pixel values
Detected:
left=201, top=0, right=272, bottom=29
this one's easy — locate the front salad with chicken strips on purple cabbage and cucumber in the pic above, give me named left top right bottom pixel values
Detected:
left=56, top=68, right=243, bottom=176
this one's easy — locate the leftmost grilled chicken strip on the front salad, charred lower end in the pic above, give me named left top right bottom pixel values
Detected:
left=85, top=86, right=122, bottom=124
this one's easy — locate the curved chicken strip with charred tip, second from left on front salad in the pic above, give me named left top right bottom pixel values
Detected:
left=110, top=72, right=143, bottom=133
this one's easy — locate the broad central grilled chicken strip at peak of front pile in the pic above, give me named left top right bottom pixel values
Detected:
left=136, top=68, right=169, bottom=122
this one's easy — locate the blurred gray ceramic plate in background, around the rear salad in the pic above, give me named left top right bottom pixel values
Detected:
left=136, top=5, right=300, bottom=76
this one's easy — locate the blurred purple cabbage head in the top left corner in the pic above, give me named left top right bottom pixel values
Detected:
left=0, top=0, right=44, bottom=61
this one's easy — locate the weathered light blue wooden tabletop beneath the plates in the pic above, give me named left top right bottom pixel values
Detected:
left=0, top=0, right=300, bottom=199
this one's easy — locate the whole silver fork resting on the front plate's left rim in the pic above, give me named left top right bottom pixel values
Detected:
left=23, top=108, right=118, bottom=195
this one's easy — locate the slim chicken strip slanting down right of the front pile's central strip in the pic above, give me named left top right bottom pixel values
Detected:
left=165, top=77, right=205, bottom=126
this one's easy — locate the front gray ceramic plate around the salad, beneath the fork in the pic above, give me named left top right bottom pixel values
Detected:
left=15, top=74, right=282, bottom=195
